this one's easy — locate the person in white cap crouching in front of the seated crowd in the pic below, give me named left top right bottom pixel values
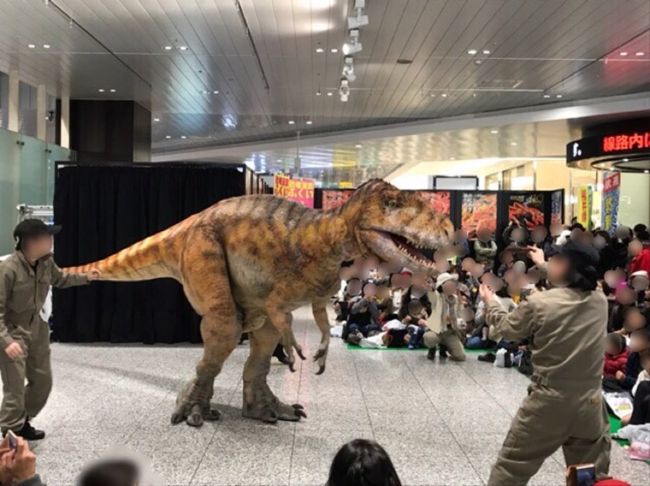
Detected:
left=422, top=272, right=465, bottom=361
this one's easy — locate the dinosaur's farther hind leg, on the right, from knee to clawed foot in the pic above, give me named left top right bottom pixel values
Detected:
left=242, top=319, right=307, bottom=423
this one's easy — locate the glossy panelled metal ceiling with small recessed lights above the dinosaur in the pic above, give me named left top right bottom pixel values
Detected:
left=0, top=0, right=650, bottom=175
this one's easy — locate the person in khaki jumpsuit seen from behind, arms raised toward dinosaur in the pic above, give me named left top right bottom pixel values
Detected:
left=480, top=242, right=611, bottom=486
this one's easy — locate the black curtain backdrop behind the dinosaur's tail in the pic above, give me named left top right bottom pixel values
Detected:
left=53, top=165, right=245, bottom=344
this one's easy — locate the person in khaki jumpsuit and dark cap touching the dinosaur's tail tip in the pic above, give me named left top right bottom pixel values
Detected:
left=0, top=219, right=98, bottom=440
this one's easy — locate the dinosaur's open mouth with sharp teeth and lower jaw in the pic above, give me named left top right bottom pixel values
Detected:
left=359, top=229, right=435, bottom=270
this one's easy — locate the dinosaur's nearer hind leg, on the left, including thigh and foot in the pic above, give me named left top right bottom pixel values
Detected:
left=171, top=231, right=241, bottom=427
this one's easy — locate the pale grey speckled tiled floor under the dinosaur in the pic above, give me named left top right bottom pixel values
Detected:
left=15, top=311, right=650, bottom=486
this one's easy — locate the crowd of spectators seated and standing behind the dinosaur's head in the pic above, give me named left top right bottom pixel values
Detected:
left=334, top=221, right=650, bottom=425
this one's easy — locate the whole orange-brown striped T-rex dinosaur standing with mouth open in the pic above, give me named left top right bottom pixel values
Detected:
left=66, top=180, right=453, bottom=426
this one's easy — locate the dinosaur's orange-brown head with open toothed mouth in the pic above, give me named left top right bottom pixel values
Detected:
left=344, top=179, right=454, bottom=270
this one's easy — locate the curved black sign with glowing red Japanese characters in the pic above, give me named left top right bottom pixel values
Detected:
left=566, top=130, right=650, bottom=162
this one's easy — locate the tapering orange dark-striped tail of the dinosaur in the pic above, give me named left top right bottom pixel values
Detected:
left=63, top=216, right=194, bottom=282
